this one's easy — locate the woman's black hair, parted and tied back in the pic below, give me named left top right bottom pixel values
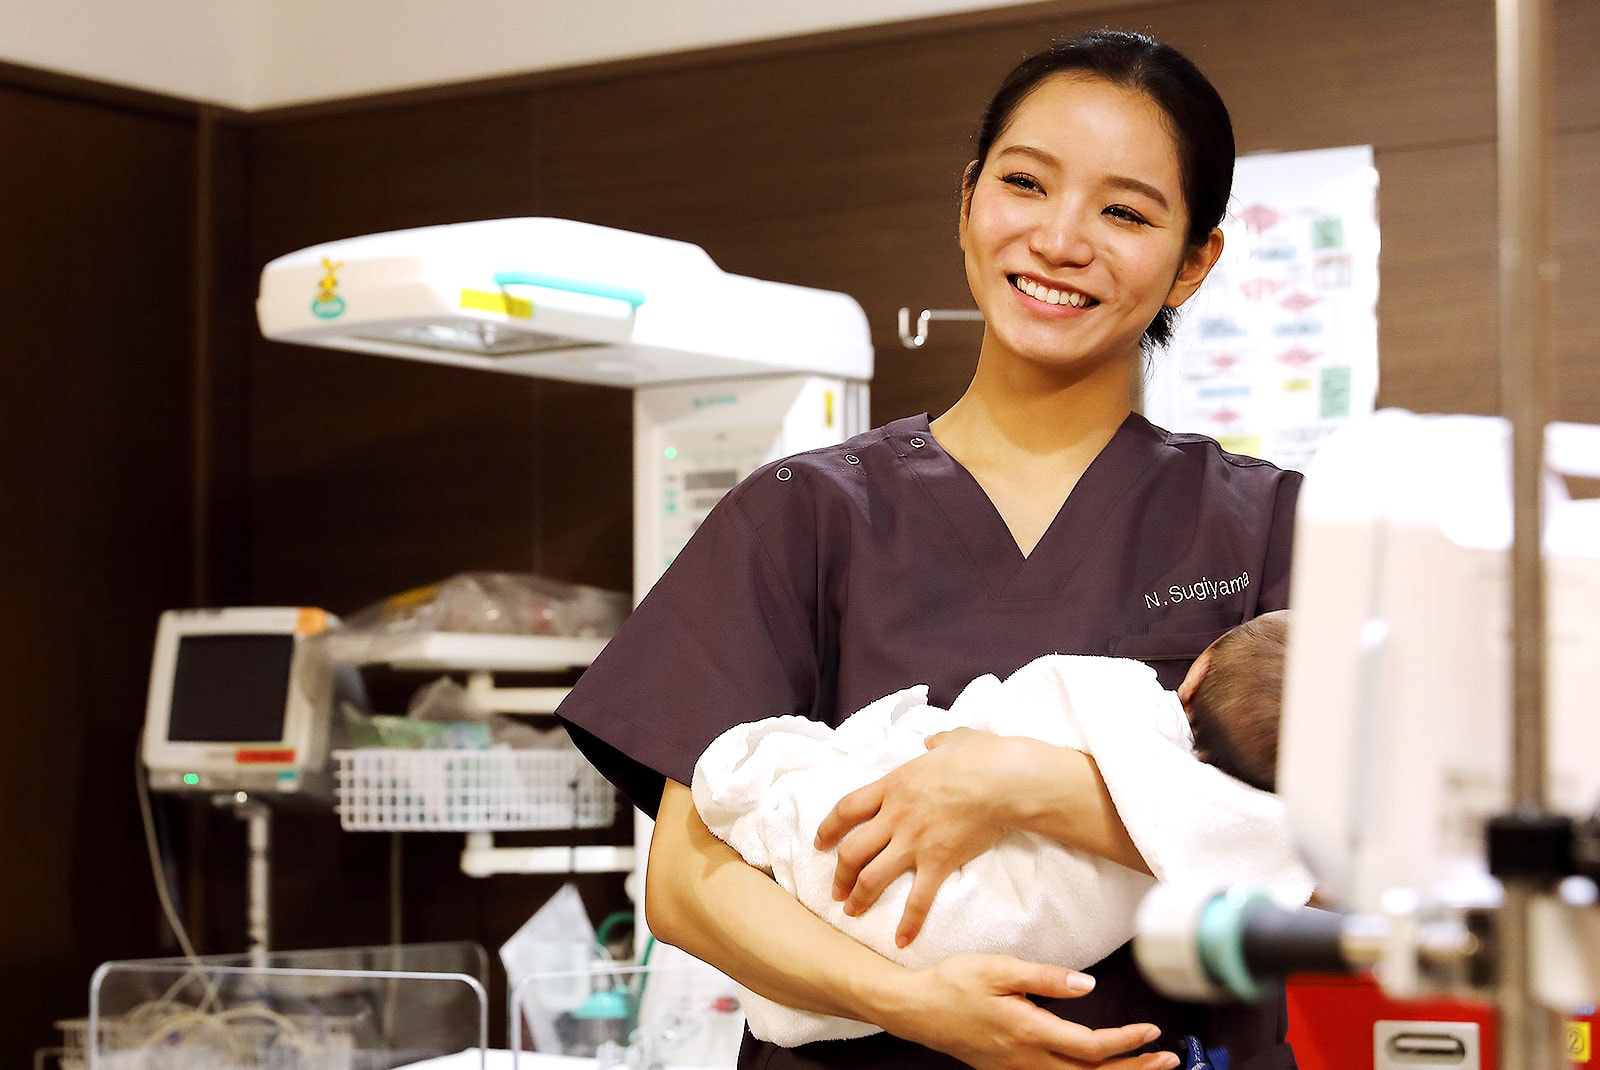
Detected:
left=965, top=30, right=1234, bottom=345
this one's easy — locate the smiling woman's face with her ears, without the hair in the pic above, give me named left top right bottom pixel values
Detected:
left=962, top=74, right=1222, bottom=374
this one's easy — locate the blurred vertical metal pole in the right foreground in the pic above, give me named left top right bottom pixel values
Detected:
left=1494, top=0, right=1562, bottom=1070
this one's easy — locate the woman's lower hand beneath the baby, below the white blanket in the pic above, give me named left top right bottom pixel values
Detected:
left=883, top=955, right=1178, bottom=1070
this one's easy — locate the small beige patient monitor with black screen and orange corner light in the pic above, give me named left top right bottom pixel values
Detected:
left=142, top=606, right=347, bottom=798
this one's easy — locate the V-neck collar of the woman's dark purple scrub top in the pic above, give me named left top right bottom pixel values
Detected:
left=885, top=413, right=1162, bottom=598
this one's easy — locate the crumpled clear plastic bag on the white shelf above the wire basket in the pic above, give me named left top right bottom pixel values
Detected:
left=344, top=573, right=630, bottom=638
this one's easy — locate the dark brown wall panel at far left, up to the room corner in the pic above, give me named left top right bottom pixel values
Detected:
left=0, top=77, right=204, bottom=1065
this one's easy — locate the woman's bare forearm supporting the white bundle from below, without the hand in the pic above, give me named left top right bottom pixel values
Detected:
left=645, top=781, right=912, bottom=1028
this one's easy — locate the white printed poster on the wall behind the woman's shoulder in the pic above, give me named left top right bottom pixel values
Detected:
left=1142, top=146, right=1378, bottom=470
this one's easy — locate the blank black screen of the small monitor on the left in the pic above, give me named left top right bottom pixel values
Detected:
left=166, top=633, right=294, bottom=744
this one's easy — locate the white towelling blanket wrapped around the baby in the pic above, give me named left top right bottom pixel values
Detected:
left=691, top=654, right=1312, bottom=1046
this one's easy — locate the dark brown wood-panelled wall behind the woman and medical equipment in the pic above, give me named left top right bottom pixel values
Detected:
left=0, top=0, right=1600, bottom=1062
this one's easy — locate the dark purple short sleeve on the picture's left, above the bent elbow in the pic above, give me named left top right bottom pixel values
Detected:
left=557, top=469, right=818, bottom=816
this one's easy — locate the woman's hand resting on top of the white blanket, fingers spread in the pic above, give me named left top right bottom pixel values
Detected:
left=816, top=728, right=1034, bottom=947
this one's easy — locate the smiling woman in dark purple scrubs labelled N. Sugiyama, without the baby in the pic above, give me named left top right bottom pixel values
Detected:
left=560, top=24, right=1299, bottom=1070
